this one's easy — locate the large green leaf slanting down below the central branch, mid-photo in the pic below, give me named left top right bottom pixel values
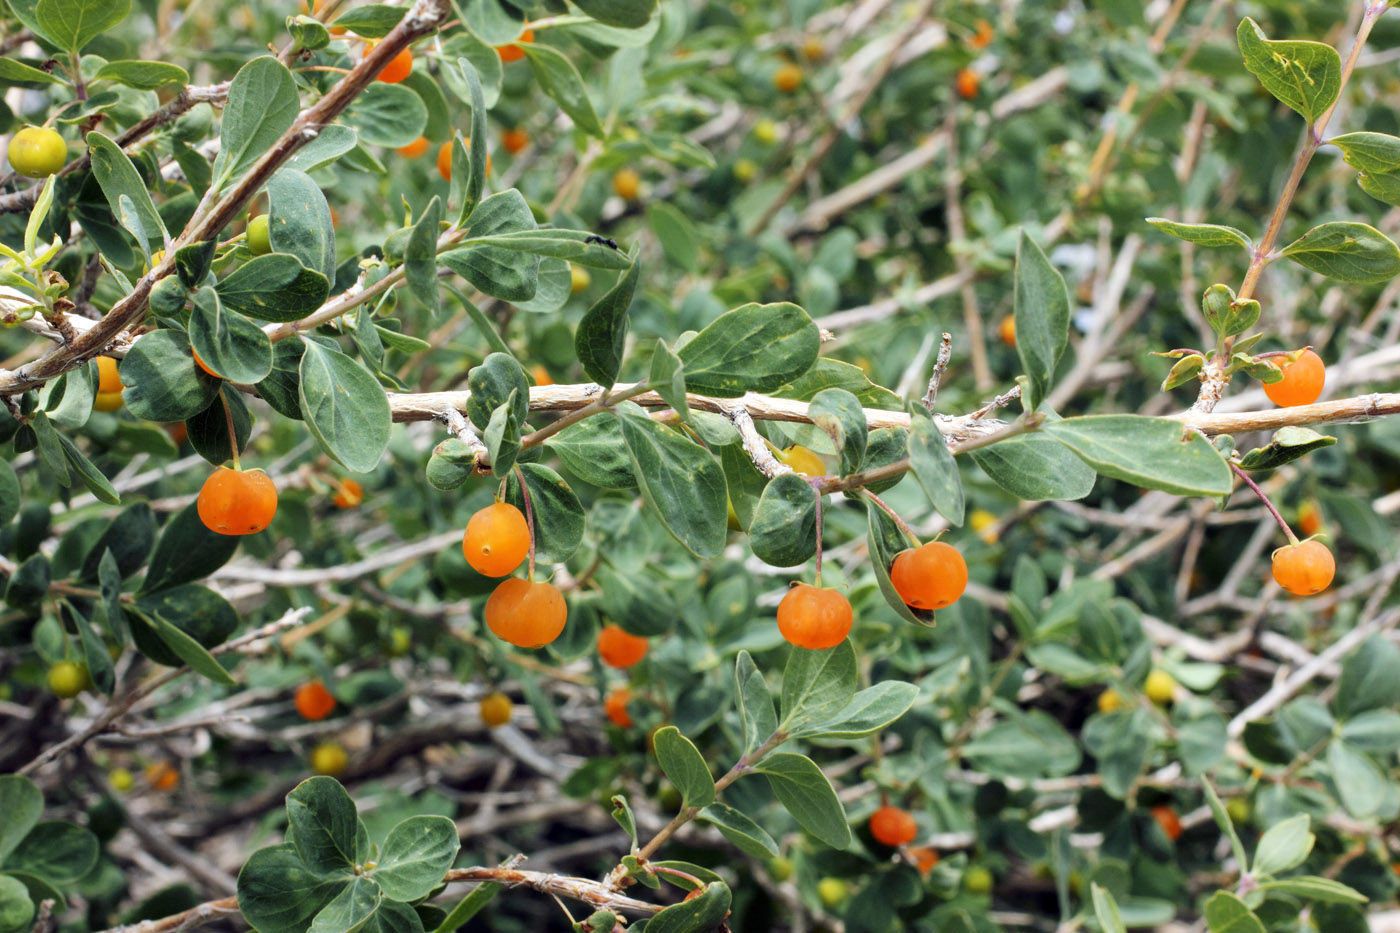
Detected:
left=613, top=402, right=728, bottom=558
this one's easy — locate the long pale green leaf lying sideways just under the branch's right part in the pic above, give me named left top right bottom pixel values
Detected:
left=1040, top=415, right=1233, bottom=496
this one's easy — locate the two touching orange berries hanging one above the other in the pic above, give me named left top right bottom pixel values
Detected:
left=462, top=502, right=568, bottom=647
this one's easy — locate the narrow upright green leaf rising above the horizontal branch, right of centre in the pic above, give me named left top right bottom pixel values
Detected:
left=1015, top=230, right=1070, bottom=409
